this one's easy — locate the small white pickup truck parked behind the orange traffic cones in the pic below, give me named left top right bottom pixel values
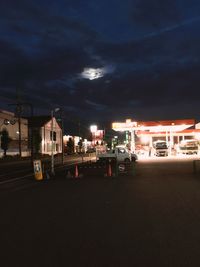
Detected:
left=96, top=146, right=132, bottom=162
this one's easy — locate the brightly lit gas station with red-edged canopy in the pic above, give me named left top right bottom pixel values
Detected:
left=112, top=119, right=200, bottom=155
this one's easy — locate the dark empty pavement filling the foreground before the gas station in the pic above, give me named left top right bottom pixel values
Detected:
left=0, top=161, right=200, bottom=267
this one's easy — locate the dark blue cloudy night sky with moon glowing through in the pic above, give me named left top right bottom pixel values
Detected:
left=0, top=0, right=200, bottom=133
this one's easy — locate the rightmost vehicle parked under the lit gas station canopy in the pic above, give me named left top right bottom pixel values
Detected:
left=178, top=139, right=199, bottom=155
